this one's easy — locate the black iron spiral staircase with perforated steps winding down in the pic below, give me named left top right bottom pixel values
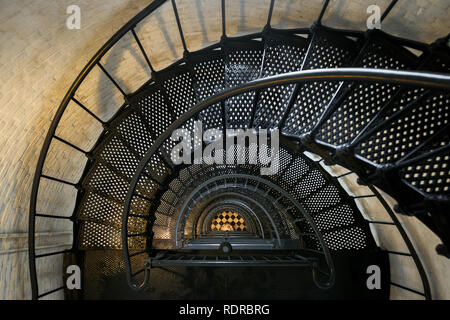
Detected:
left=29, top=0, right=450, bottom=299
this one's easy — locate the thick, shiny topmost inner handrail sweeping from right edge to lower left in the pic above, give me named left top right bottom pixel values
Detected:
left=122, top=68, right=450, bottom=292
